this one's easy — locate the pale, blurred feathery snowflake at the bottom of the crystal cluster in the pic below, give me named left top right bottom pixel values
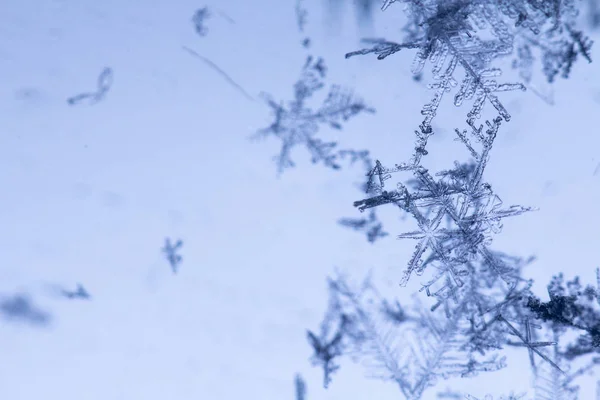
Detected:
left=310, top=270, right=505, bottom=399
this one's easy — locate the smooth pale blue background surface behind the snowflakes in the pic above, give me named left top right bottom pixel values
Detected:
left=0, top=0, right=600, bottom=400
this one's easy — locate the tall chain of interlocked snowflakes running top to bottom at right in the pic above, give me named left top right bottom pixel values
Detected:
left=309, top=0, right=600, bottom=400
